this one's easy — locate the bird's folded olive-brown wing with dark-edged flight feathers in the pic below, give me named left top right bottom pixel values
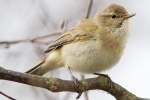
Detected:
left=44, top=24, right=97, bottom=53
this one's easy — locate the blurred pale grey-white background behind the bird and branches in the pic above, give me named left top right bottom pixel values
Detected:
left=0, top=0, right=150, bottom=100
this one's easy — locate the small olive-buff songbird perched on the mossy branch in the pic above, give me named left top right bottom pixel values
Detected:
left=26, top=4, right=135, bottom=82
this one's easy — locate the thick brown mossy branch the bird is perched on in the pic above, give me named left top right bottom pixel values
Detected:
left=0, top=67, right=150, bottom=100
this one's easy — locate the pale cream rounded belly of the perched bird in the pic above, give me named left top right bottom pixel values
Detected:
left=62, top=41, right=122, bottom=74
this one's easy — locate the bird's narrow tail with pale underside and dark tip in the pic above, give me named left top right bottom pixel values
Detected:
left=25, top=52, right=64, bottom=76
